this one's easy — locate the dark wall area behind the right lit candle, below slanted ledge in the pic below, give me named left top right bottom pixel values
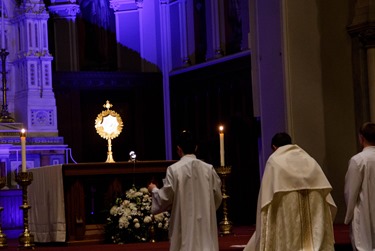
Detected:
left=170, top=55, right=259, bottom=225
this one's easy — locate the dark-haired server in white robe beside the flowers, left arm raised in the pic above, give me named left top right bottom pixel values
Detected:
left=148, top=131, right=222, bottom=251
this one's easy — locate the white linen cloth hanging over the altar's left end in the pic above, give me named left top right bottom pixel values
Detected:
left=28, top=165, right=66, bottom=242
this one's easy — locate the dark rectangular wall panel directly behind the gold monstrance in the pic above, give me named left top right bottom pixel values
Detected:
left=53, top=72, right=165, bottom=162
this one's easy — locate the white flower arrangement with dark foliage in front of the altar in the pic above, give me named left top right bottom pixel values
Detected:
left=105, top=187, right=170, bottom=244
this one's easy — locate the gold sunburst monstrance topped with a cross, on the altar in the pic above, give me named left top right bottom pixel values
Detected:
left=95, top=100, right=123, bottom=162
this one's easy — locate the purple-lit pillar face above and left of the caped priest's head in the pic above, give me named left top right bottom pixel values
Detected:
left=252, top=0, right=286, bottom=174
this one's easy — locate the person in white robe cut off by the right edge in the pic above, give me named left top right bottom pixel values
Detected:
left=344, top=122, right=375, bottom=251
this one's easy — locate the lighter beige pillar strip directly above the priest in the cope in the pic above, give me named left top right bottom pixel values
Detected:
left=283, top=1, right=326, bottom=165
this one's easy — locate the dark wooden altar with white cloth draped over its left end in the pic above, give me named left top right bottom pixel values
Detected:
left=28, top=160, right=175, bottom=243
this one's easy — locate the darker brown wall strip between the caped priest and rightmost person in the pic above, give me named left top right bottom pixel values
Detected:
left=318, top=0, right=356, bottom=222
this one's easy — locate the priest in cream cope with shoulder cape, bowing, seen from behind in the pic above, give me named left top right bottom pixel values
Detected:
left=244, top=132, right=337, bottom=251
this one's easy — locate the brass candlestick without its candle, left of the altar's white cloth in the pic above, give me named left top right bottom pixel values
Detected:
left=16, top=172, right=35, bottom=249
